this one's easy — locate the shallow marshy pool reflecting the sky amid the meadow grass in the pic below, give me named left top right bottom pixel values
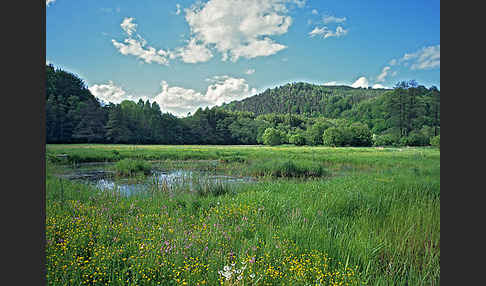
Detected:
left=59, top=163, right=255, bottom=196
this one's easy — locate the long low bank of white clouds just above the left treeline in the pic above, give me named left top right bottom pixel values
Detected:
left=89, top=75, right=257, bottom=116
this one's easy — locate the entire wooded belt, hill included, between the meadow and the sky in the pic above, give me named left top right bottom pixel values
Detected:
left=46, top=65, right=440, bottom=146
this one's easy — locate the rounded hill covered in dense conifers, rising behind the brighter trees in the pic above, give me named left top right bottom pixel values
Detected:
left=221, top=82, right=387, bottom=118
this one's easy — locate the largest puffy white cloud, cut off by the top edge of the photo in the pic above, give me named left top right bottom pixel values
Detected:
left=184, top=0, right=305, bottom=62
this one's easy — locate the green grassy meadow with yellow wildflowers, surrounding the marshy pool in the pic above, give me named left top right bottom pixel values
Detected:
left=46, top=144, right=440, bottom=285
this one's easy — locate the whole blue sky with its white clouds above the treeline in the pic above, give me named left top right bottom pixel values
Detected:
left=46, top=0, right=440, bottom=117
